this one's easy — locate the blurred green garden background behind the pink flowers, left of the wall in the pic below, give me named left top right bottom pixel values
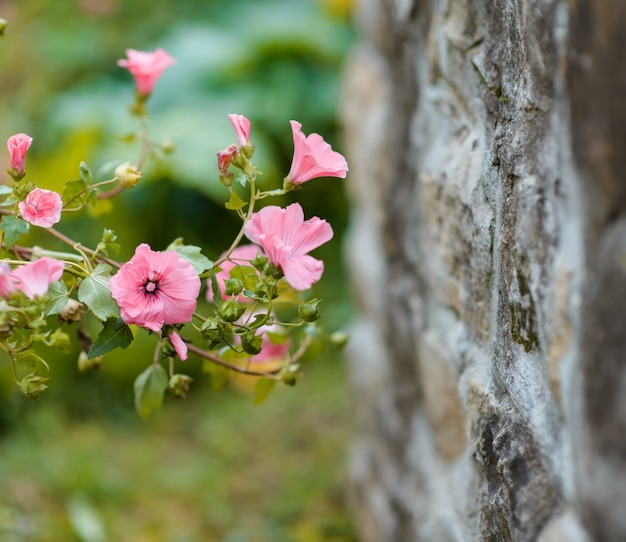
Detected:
left=0, top=0, right=355, bottom=542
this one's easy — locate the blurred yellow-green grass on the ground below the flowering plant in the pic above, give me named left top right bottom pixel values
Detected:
left=0, top=358, right=355, bottom=542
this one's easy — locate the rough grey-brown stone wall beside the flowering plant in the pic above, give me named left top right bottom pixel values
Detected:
left=342, top=0, right=626, bottom=542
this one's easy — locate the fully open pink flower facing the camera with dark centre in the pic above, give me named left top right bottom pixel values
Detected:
left=109, top=243, right=200, bottom=331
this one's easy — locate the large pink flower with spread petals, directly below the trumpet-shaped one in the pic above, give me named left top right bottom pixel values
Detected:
left=245, top=203, right=333, bottom=290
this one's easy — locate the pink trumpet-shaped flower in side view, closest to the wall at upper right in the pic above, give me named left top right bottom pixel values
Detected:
left=285, top=120, right=348, bottom=184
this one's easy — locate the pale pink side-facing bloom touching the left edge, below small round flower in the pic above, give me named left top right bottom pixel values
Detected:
left=0, top=258, right=65, bottom=299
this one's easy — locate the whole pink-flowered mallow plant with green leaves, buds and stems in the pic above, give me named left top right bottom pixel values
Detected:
left=0, top=40, right=348, bottom=417
